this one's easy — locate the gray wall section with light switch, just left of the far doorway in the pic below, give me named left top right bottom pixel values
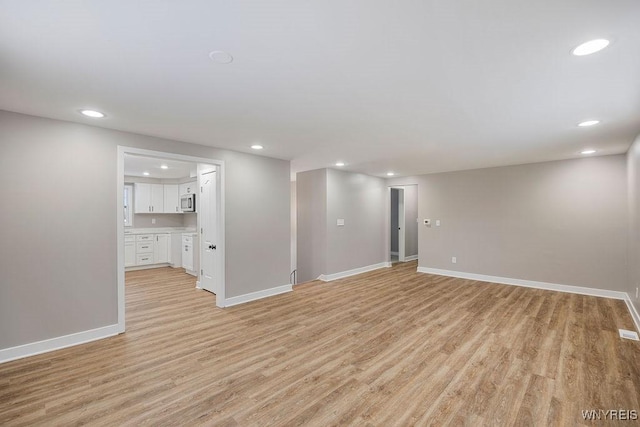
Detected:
left=325, top=169, right=389, bottom=274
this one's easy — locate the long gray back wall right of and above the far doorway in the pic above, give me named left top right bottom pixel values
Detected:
left=388, top=155, right=628, bottom=291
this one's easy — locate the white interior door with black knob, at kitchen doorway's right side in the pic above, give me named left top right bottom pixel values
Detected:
left=196, top=165, right=220, bottom=294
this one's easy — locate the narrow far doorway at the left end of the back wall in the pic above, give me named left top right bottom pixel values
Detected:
left=389, top=185, right=418, bottom=263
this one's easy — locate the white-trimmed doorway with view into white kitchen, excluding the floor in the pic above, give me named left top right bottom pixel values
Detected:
left=117, top=146, right=225, bottom=332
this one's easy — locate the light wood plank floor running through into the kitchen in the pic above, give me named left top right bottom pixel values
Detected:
left=0, top=262, right=640, bottom=426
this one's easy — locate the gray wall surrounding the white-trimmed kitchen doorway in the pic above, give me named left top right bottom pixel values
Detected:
left=0, top=112, right=290, bottom=349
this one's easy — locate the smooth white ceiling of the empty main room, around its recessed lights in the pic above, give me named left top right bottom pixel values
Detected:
left=0, top=0, right=640, bottom=176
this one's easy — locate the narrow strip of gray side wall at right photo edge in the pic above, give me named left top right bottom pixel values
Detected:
left=627, top=136, right=640, bottom=312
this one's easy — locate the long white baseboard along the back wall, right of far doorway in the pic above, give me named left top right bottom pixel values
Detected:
left=418, top=267, right=628, bottom=300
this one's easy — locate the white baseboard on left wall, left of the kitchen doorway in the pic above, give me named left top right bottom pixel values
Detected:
left=0, top=325, right=121, bottom=363
